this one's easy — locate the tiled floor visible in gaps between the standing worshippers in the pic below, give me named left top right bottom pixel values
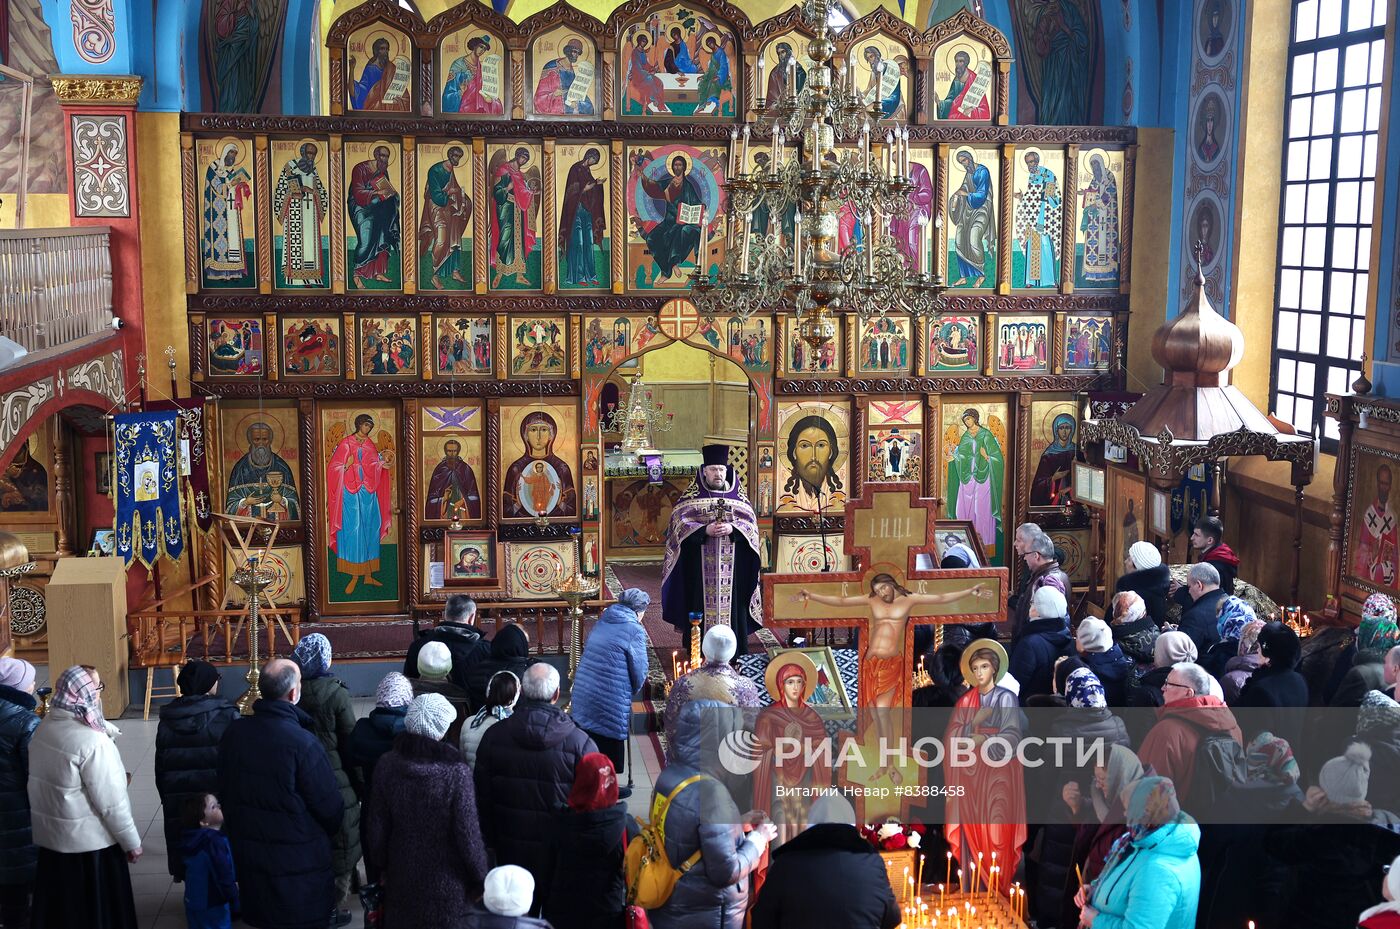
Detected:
left=116, top=700, right=658, bottom=929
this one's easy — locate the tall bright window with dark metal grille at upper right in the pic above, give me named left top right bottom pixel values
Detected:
left=1270, top=0, right=1390, bottom=452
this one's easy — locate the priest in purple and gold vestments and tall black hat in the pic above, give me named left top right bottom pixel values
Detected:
left=661, top=445, right=762, bottom=655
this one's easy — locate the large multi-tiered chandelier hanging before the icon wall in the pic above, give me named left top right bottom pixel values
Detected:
left=690, top=0, right=946, bottom=355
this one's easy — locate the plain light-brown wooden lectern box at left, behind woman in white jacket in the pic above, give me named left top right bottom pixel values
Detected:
left=45, top=558, right=130, bottom=719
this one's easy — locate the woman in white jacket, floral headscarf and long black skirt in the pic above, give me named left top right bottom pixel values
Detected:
left=29, top=665, right=141, bottom=929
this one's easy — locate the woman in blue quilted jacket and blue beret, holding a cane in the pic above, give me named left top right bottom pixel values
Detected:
left=570, top=588, right=651, bottom=797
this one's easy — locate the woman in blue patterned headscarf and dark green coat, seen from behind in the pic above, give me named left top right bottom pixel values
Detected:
left=291, top=632, right=363, bottom=925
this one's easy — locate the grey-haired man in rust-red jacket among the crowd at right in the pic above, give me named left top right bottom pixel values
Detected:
left=1138, top=662, right=1245, bottom=809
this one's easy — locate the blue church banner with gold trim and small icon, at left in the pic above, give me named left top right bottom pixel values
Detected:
left=113, top=410, right=185, bottom=568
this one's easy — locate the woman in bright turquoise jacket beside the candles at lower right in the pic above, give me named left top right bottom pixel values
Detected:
left=1077, top=778, right=1201, bottom=929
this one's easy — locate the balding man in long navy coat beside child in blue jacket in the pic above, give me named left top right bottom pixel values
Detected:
left=218, top=658, right=344, bottom=929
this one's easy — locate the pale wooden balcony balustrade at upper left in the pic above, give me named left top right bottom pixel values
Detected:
left=0, top=225, right=112, bottom=361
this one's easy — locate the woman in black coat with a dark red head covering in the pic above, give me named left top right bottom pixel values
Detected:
left=543, top=751, right=631, bottom=929
